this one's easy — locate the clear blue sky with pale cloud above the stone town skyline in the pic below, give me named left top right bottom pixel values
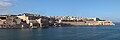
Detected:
left=0, top=0, right=120, bottom=22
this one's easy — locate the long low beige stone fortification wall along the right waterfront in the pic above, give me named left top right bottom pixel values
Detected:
left=61, top=21, right=114, bottom=26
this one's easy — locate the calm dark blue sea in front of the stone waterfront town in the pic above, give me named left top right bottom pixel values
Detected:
left=0, top=23, right=120, bottom=40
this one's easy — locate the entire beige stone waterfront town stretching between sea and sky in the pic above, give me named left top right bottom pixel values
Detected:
left=0, top=13, right=115, bottom=28
